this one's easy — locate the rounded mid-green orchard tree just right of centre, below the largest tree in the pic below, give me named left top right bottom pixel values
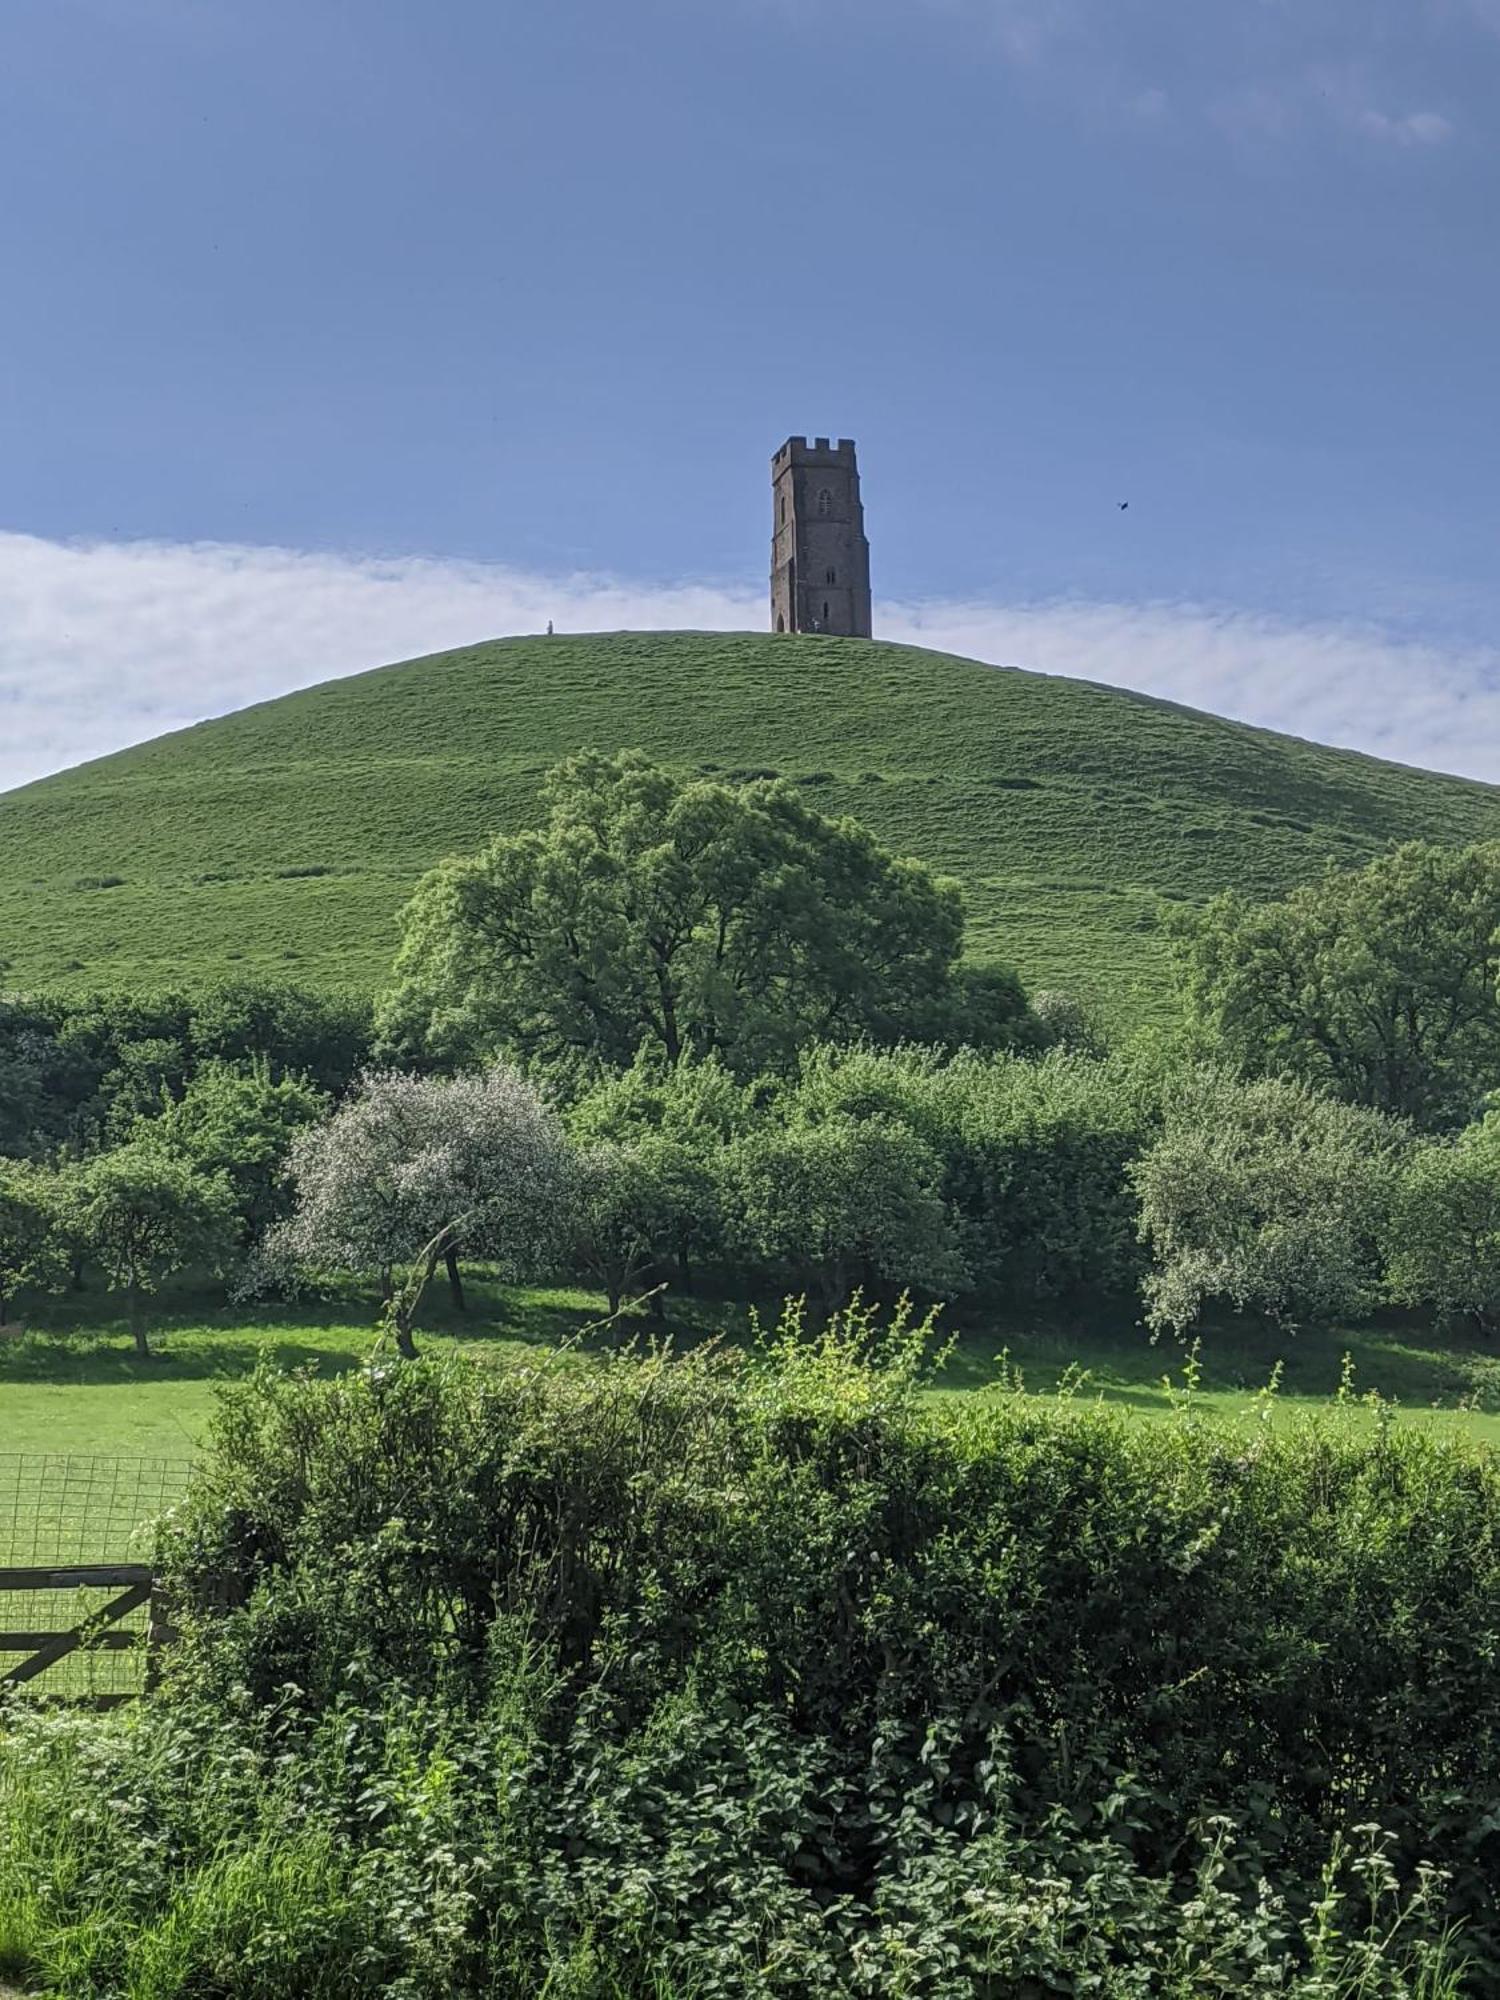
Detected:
left=724, top=1114, right=964, bottom=1312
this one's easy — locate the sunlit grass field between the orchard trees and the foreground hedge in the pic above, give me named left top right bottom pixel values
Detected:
left=0, top=1284, right=1500, bottom=1458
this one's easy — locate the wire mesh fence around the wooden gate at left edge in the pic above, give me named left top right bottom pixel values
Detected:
left=0, top=1452, right=190, bottom=1700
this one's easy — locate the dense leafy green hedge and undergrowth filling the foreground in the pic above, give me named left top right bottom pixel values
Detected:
left=0, top=1324, right=1500, bottom=2000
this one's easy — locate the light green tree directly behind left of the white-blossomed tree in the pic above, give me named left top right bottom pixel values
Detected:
left=136, top=1056, right=328, bottom=1244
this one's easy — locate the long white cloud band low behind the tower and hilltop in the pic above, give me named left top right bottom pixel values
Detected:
left=0, top=534, right=1500, bottom=786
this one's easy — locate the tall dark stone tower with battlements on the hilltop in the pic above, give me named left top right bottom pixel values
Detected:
left=770, top=438, right=870, bottom=638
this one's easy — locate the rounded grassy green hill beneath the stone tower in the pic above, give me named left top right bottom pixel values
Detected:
left=0, top=632, right=1500, bottom=1016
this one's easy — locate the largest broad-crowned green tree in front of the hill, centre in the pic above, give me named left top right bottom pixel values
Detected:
left=378, top=752, right=1028, bottom=1076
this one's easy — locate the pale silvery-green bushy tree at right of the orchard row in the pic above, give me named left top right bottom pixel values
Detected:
left=1130, top=1074, right=1408, bottom=1334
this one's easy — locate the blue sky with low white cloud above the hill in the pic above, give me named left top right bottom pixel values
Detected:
left=0, top=0, right=1500, bottom=786
